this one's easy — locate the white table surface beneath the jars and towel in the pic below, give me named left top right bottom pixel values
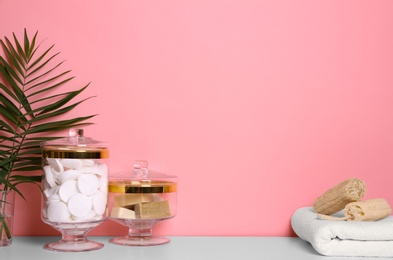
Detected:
left=0, top=236, right=393, bottom=260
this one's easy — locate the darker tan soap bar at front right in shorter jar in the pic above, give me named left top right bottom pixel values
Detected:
left=135, top=200, right=171, bottom=219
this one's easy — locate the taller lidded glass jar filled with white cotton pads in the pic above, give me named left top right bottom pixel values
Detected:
left=41, top=129, right=109, bottom=252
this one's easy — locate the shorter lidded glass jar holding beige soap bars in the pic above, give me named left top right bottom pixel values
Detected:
left=108, top=161, right=177, bottom=246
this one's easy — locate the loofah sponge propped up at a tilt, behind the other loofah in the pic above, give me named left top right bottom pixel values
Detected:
left=313, top=178, right=366, bottom=215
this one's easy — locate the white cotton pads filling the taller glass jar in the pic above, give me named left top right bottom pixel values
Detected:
left=42, top=158, right=108, bottom=222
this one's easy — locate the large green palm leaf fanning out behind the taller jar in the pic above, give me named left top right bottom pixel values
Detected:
left=0, top=29, right=96, bottom=205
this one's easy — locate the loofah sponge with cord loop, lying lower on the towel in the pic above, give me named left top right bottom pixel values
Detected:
left=318, top=198, right=392, bottom=221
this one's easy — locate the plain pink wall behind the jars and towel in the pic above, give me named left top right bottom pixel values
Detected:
left=0, top=0, right=393, bottom=236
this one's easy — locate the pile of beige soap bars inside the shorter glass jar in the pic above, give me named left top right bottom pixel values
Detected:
left=110, top=193, right=171, bottom=219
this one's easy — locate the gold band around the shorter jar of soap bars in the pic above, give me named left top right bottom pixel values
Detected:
left=108, top=181, right=177, bottom=193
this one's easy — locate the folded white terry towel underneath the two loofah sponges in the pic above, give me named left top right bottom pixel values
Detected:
left=291, top=207, right=393, bottom=257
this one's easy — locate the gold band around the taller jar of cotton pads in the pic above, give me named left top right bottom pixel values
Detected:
left=42, top=148, right=109, bottom=159
